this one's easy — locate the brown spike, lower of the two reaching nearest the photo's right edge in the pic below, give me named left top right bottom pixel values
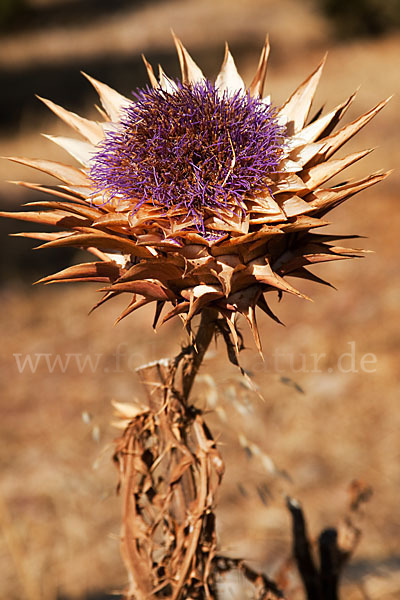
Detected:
left=305, top=171, right=391, bottom=216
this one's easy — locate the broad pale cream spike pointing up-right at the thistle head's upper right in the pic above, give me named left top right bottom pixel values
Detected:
left=278, top=55, right=327, bottom=134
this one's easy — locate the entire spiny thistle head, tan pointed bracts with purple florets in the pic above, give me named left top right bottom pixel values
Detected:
left=2, top=38, right=387, bottom=349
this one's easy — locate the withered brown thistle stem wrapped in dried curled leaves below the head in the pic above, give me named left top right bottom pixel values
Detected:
left=115, top=309, right=224, bottom=600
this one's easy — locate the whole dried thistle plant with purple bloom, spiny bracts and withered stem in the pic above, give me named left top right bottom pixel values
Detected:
left=1, top=38, right=387, bottom=600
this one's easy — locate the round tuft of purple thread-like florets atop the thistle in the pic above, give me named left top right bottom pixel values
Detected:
left=90, top=82, right=284, bottom=232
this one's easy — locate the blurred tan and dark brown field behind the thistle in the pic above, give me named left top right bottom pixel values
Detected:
left=0, top=0, right=400, bottom=600
